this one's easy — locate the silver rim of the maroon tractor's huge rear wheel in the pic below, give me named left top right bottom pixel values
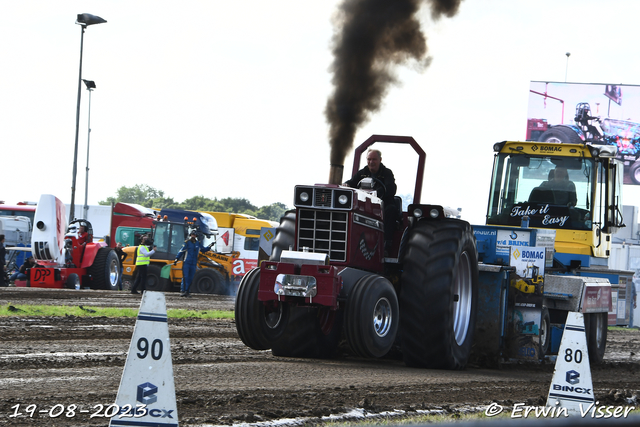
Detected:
left=453, top=252, right=473, bottom=345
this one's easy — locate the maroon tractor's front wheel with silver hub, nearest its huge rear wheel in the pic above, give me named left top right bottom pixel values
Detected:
left=344, top=274, right=400, bottom=357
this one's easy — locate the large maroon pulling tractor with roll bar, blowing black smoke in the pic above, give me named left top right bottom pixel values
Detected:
left=235, top=135, right=478, bottom=369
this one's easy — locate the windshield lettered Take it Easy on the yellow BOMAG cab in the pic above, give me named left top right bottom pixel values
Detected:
left=487, top=151, right=603, bottom=230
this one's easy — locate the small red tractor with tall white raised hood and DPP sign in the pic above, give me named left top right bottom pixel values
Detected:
left=27, top=194, right=120, bottom=290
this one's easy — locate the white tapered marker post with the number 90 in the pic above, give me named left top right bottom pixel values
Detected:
left=109, top=291, right=178, bottom=427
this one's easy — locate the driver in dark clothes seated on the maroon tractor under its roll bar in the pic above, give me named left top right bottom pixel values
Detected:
left=344, top=148, right=398, bottom=256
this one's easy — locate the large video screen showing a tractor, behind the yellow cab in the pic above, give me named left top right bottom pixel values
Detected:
left=526, top=81, right=640, bottom=185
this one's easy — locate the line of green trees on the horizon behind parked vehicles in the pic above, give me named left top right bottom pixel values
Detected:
left=98, top=184, right=288, bottom=221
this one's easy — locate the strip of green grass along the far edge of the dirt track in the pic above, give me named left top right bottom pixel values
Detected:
left=0, top=303, right=234, bottom=319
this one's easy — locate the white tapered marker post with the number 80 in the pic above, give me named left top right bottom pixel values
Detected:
left=547, top=312, right=595, bottom=415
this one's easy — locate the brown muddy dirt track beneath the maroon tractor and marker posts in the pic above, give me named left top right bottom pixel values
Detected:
left=0, top=288, right=640, bottom=426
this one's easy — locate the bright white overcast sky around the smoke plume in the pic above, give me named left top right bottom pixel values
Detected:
left=0, top=0, right=640, bottom=223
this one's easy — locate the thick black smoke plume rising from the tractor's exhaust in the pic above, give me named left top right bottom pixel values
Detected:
left=325, top=0, right=462, bottom=165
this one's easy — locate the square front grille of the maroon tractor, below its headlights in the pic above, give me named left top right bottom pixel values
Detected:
left=298, top=209, right=349, bottom=262
